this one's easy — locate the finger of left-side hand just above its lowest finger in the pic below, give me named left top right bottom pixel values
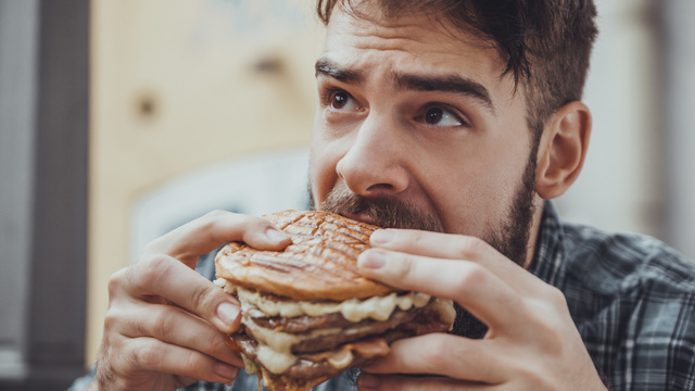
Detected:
left=116, top=303, right=243, bottom=368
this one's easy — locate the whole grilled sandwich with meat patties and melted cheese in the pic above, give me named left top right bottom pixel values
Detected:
left=215, top=210, right=456, bottom=391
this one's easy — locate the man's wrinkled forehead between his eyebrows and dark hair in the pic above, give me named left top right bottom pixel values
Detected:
left=322, top=7, right=506, bottom=83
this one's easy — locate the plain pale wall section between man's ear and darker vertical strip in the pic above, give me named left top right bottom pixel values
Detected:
left=558, top=0, right=665, bottom=237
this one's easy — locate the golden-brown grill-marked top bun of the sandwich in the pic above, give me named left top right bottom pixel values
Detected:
left=215, top=210, right=396, bottom=301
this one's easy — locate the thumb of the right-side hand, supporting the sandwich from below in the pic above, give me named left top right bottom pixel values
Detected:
left=362, top=333, right=504, bottom=383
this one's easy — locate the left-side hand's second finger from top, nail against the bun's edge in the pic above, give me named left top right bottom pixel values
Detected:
left=122, top=255, right=245, bottom=334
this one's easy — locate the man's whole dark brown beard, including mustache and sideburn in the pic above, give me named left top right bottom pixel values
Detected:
left=308, top=150, right=537, bottom=339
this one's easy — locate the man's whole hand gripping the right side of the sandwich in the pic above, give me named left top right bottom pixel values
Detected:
left=358, top=229, right=605, bottom=391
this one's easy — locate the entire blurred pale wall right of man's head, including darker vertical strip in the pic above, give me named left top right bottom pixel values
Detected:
left=558, top=0, right=695, bottom=259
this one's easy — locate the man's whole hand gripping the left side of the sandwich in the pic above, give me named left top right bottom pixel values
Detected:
left=97, top=211, right=290, bottom=390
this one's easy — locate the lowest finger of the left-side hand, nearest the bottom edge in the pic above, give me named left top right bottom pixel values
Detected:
left=122, top=337, right=239, bottom=384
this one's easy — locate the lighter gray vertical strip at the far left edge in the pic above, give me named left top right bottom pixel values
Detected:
left=0, top=0, right=38, bottom=379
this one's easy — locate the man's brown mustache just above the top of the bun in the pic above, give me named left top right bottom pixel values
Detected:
left=319, top=185, right=444, bottom=232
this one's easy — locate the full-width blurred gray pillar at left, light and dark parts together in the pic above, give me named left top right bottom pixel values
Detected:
left=0, top=0, right=89, bottom=390
